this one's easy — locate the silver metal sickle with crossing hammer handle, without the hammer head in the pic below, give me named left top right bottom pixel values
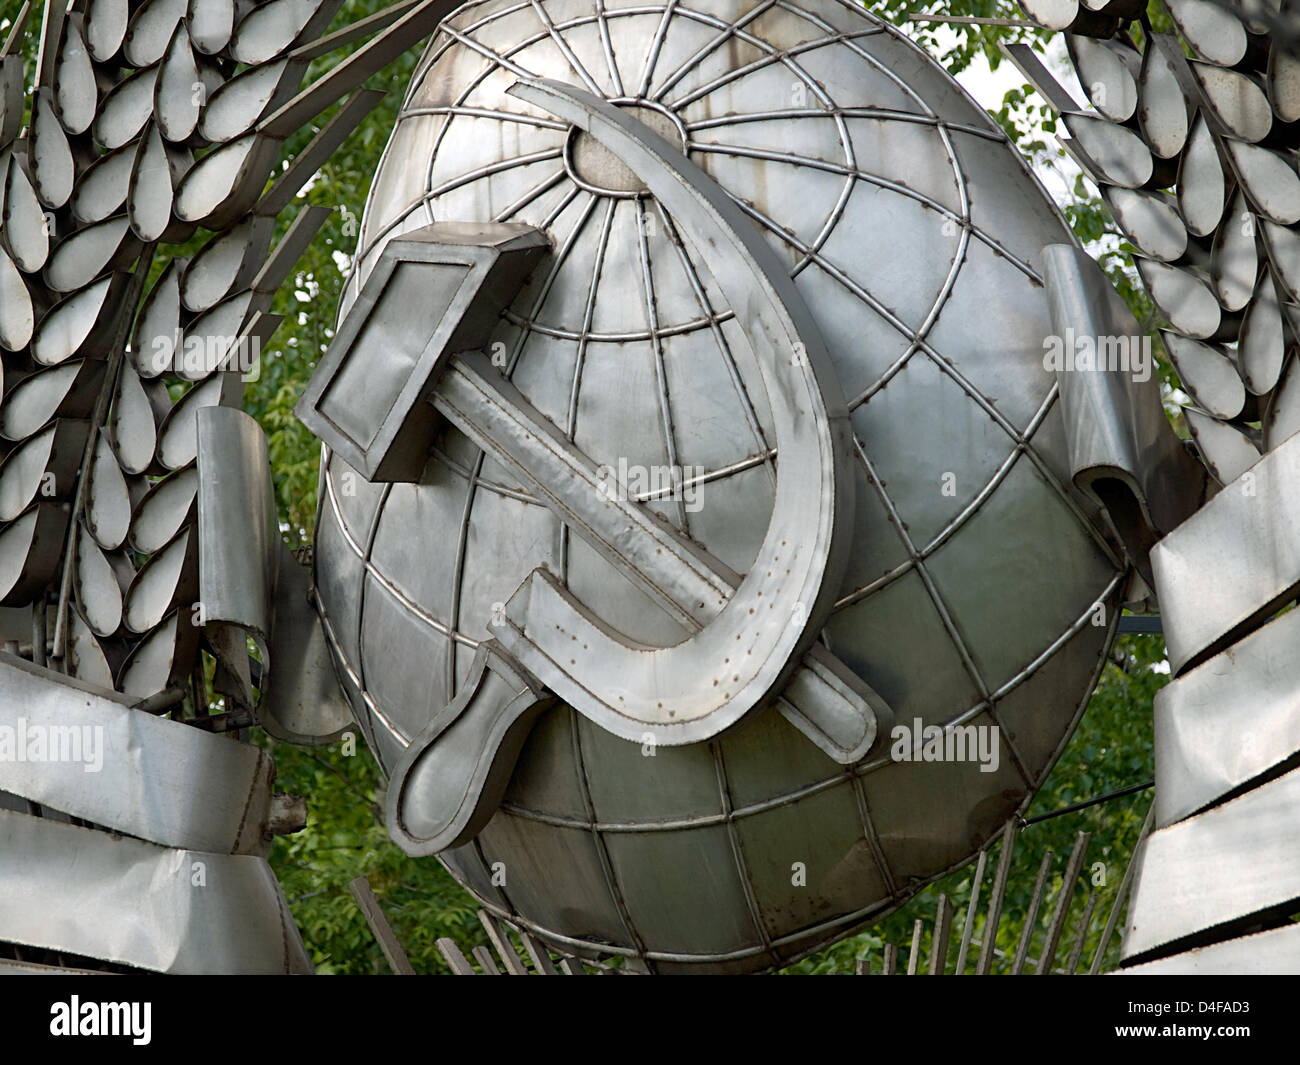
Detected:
left=304, top=79, right=891, bottom=854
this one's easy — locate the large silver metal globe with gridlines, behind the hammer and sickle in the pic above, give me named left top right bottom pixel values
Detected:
left=316, top=0, right=1125, bottom=973
